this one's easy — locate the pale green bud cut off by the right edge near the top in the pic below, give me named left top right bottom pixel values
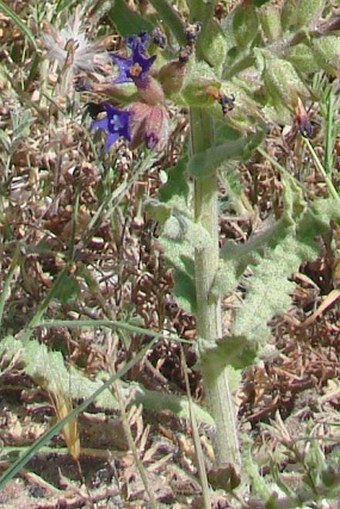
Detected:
left=313, top=35, right=340, bottom=76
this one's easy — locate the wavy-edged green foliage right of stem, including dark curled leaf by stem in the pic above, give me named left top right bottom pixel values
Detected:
left=202, top=180, right=340, bottom=370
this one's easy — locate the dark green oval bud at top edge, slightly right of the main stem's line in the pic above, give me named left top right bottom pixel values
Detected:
left=233, top=0, right=259, bottom=49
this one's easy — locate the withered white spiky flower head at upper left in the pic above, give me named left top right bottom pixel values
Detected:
left=43, top=9, right=110, bottom=72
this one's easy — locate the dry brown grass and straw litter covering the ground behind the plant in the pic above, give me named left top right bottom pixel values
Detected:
left=0, top=2, right=340, bottom=508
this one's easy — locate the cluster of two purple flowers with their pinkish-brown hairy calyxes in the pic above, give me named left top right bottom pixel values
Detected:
left=91, top=32, right=169, bottom=150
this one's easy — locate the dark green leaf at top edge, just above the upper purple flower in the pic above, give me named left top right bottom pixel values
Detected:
left=108, top=0, right=154, bottom=37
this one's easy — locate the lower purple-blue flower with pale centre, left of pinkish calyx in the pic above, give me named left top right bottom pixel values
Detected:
left=91, top=102, right=131, bottom=152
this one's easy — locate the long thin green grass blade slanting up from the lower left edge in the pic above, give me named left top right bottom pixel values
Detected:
left=0, top=338, right=157, bottom=490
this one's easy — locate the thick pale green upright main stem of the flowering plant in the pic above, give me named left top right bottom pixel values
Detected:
left=190, top=108, right=241, bottom=468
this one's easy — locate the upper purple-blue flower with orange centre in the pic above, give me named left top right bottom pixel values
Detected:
left=111, top=32, right=156, bottom=86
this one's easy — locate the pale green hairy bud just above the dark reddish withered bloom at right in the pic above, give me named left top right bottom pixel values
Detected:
left=263, top=52, right=310, bottom=106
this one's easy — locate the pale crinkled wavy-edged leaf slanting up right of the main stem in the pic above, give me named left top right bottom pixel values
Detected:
left=232, top=197, right=340, bottom=345
